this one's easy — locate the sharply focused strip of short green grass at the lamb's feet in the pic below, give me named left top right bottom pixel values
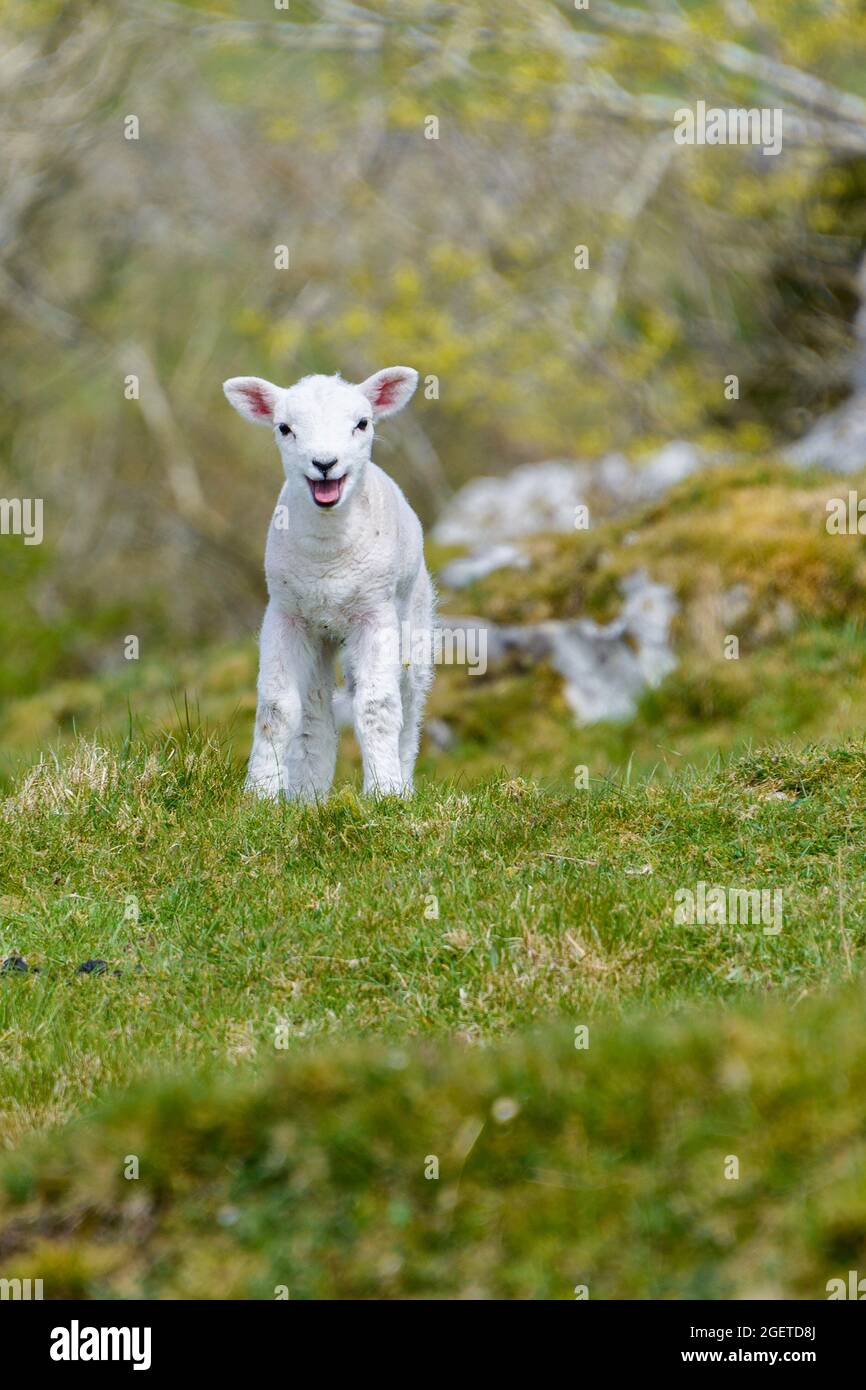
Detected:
left=0, top=731, right=866, bottom=1143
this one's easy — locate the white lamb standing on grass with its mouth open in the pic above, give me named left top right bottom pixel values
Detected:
left=222, top=367, right=434, bottom=801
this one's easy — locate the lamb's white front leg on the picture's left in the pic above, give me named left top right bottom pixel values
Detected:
left=246, top=603, right=316, bottom=796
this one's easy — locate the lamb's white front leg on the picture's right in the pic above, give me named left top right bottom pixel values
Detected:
left=346, top=606, right=405, bottom=795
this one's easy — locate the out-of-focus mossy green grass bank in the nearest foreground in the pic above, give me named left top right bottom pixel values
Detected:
left=0, top=986, right=866, bottom=1300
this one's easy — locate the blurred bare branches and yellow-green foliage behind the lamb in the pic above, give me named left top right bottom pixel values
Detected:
left=0, top=0, right=866, bottom=750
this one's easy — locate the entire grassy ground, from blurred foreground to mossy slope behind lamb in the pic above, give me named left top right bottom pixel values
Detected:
left=0, top=467, right=866, bottom=1298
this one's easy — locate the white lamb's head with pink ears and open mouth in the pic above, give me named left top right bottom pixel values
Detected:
left=222, top=367, right=418, bottom=510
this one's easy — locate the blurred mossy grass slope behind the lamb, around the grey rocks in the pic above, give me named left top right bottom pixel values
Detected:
left=0, top=463, right=866, bottom=788
